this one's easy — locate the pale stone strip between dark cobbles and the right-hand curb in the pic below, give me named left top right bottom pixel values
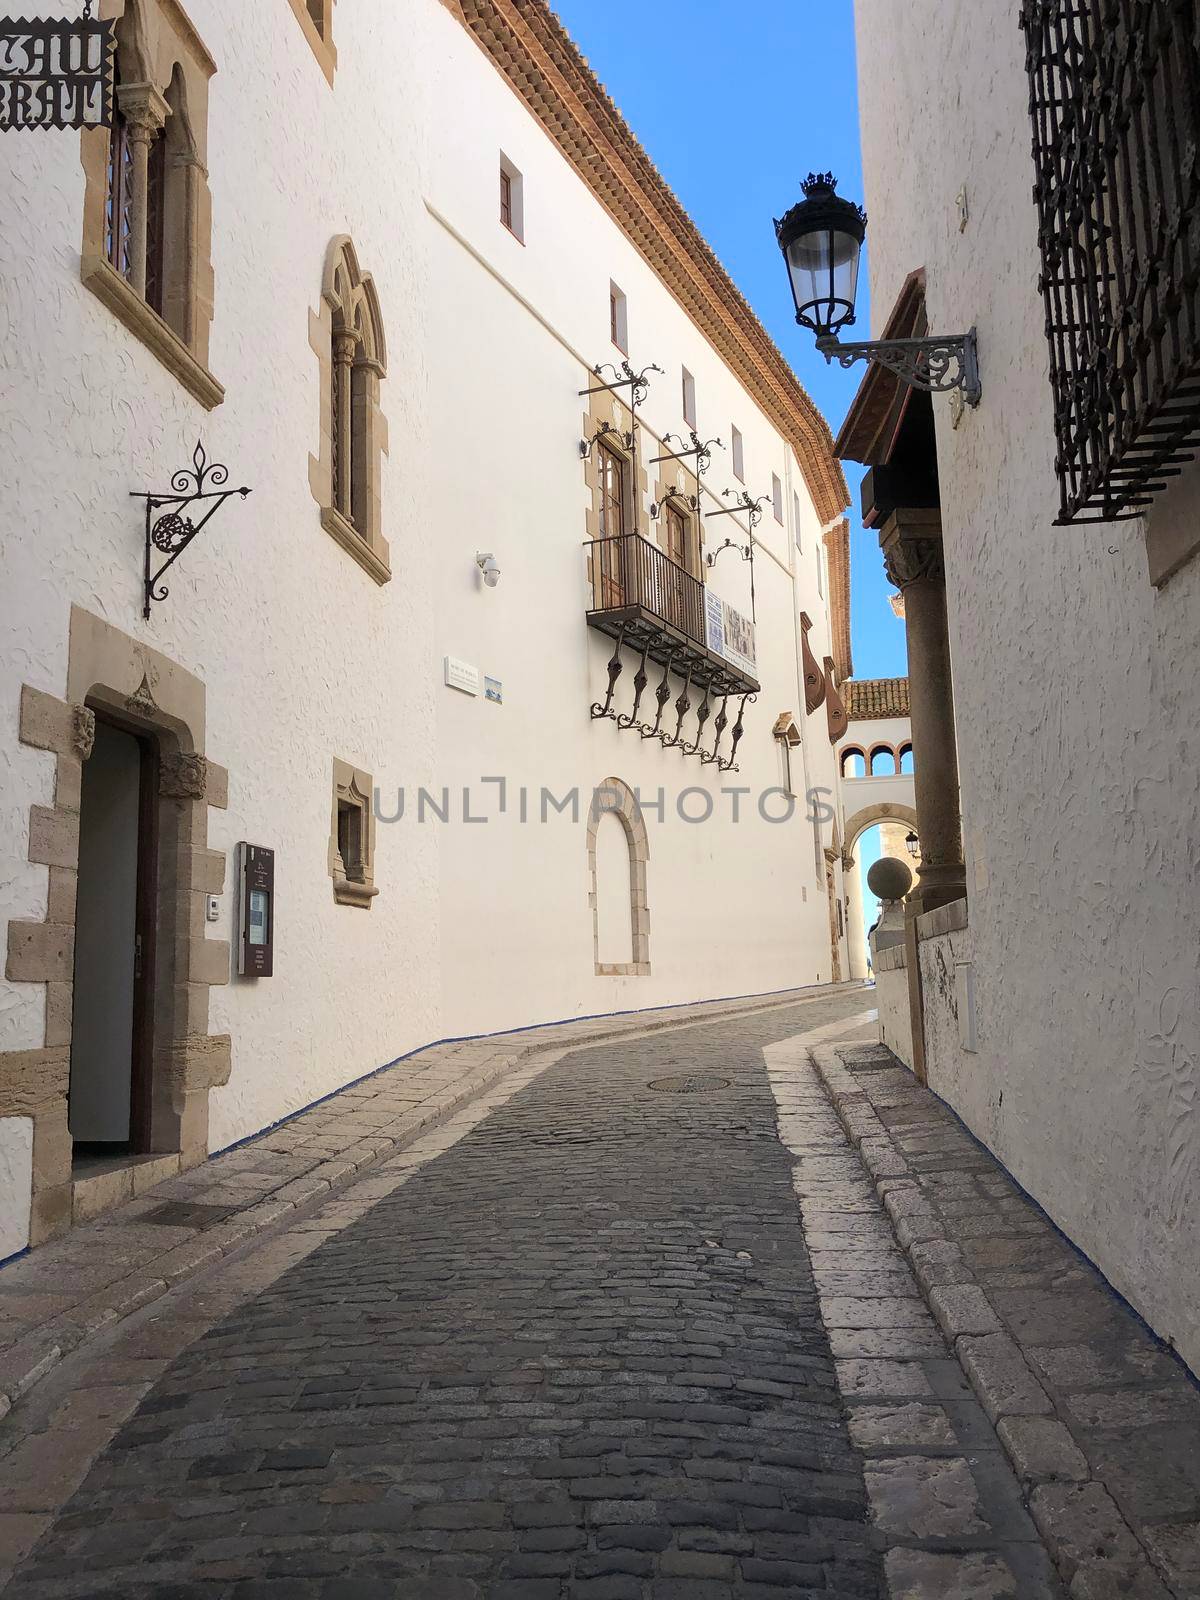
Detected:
left=763, top=1024, right=1062, bottom=1600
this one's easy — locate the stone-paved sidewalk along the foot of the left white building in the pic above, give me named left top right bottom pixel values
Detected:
left=0, top=984, right=854, bottom=1419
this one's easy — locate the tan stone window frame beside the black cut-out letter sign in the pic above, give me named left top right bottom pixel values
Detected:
left=80, top=0, right=226, bottom=411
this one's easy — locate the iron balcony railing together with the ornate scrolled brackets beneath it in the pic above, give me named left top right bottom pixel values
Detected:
left=586, top=533, right=758, bottom=771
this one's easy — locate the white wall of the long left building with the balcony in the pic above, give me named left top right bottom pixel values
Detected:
left=0, top=0, right=857, bottom=1235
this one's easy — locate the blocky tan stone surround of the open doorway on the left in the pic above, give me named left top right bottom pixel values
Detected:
left=0, top=606, right=232, bottom=1245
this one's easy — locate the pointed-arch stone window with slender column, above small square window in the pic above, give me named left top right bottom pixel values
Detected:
left=309, top=234, right=392, bottom=586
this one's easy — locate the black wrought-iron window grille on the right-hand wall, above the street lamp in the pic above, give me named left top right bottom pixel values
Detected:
left=1021, top=0, right=1200, bottom=523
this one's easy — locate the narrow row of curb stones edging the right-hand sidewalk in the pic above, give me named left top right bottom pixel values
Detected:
left=810, top=1048, right=1187, bottom=1600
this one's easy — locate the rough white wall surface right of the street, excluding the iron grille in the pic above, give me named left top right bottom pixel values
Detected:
left=856, top=0, right=1200, bottom=1366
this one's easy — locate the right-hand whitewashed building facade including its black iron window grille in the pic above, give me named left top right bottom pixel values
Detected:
left=838, top=0, right=1200, bottom=1370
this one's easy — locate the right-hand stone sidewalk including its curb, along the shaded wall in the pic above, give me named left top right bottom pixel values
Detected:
left=813, top=1045, right=1200, bottom=1600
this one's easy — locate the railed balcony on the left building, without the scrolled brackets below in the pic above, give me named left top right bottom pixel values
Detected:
left=584, top=533, right=758, bottom=694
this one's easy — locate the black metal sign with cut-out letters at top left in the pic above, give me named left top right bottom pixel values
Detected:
left=0, top=5, right=115, bottom=128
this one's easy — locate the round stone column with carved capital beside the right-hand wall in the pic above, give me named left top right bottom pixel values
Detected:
left=878, top=510, right=966, bottom=914
